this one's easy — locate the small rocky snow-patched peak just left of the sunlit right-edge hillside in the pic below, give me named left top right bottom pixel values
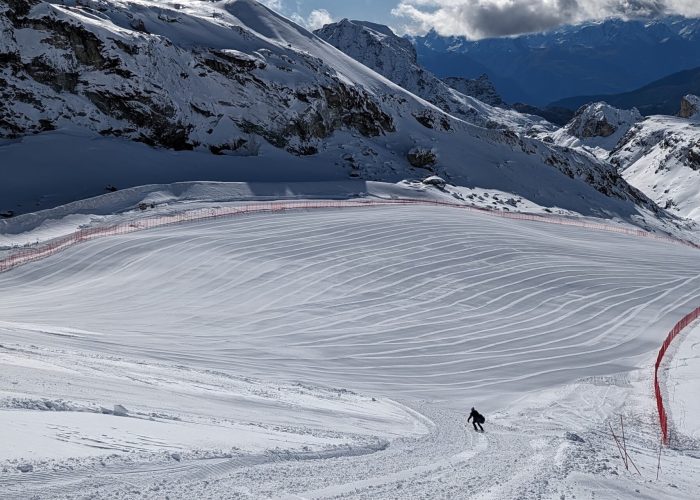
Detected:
left=552, top=102, right=642, bottom=159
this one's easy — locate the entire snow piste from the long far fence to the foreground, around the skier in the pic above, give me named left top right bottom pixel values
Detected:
left=0, top=201, right=700, bottom=499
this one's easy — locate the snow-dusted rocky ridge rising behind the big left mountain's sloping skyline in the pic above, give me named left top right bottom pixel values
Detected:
left=315, top=19, right=549, bottom=129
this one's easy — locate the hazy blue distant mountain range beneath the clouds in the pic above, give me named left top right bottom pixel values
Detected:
left=412, top=17, right=700, bottom=106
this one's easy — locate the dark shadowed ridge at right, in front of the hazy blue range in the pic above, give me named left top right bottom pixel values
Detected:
left=551, top=68, right=700, bottom=116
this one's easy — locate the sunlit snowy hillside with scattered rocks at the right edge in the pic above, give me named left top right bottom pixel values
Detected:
left=610, top=96, right=700, bottom=220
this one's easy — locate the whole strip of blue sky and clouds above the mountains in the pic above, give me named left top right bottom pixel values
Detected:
left=260, top=0, right=700, bottom=39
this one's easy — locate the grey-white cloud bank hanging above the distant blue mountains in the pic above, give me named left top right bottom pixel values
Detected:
left=392, top=0, right=700, bottom=38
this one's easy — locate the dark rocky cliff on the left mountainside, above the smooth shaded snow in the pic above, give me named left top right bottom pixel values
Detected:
left=0, top=0, right=394, bottom=154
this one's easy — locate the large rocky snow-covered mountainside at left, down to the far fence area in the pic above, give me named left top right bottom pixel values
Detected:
left=0, top=0, right=663, bottom=223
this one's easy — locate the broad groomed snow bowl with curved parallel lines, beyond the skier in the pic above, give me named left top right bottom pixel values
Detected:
left=5, top=203, right=700, bottom=404
